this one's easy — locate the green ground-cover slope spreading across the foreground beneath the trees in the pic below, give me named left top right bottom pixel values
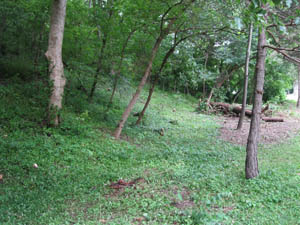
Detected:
left=0, top=80, right=300, bottom=224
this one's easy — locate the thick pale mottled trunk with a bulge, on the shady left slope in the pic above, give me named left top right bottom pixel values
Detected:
left=45, top=0, right=67, bottom=126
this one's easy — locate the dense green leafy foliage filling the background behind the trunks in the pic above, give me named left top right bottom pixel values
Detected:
left=0, top=0, right=296, bottom=102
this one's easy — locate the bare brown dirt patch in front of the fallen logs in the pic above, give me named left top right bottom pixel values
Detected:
left=220, top=117, right=300, bottom=145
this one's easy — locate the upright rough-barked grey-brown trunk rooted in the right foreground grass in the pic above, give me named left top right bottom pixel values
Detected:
left=245, top=27, right=266, bottom=179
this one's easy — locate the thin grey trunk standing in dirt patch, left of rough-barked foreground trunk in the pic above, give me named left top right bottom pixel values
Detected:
left=237, top=23, right=253, bottom=130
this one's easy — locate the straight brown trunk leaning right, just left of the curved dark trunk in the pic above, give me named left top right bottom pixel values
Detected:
left=114, top=35, right=164, bottom=139
